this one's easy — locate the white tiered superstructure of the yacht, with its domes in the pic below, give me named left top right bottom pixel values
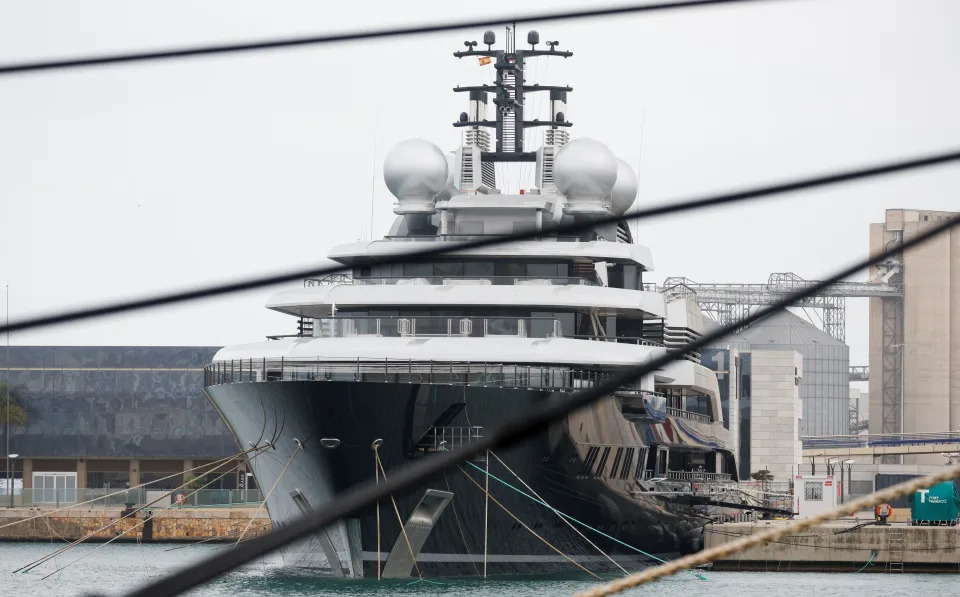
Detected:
left=217, top=132, right=722, bottom=422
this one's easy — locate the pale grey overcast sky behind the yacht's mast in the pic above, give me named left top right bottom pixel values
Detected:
left=0, top=0, right=960, bottom=364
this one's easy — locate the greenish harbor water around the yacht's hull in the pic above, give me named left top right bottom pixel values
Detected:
left=0, top=543, right=956, bottom=597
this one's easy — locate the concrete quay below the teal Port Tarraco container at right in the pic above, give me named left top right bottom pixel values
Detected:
left=704, top=518, right=960, bottom=572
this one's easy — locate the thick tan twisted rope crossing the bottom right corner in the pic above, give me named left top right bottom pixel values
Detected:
left=577, top=466, right=960, bottom=597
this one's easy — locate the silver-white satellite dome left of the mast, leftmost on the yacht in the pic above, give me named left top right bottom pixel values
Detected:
left=383, top=139, right=448, bottom=214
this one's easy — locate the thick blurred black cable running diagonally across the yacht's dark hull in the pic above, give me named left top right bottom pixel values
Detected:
left=122, top=212, right=960, bottom=597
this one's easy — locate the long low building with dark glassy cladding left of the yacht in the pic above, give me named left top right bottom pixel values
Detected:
left=0, top=346, right=243, bottom=489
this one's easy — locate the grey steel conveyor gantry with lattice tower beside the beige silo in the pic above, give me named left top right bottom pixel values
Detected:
left=660, top=268, right=903, bottom=434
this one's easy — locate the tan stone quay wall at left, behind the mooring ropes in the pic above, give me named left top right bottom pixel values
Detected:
left=0, top=507, right=272, bottom=543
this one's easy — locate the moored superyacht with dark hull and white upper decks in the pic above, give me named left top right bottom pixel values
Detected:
left=205, top=28, right=737, bottom=578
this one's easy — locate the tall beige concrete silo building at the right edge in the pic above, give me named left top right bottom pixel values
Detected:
left=869, top=209, right=960, bottom=464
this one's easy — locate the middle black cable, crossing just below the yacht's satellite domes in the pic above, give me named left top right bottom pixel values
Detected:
left=0, top=150, right=960, bottom=334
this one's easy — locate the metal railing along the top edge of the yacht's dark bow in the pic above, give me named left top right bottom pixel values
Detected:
left=203, top=358, right=615, bottom=392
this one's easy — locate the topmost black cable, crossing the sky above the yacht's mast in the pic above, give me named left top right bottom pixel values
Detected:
left=0, top=0, right=785, bottom=75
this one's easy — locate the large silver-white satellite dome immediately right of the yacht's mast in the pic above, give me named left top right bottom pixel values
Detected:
left=553, top=139, right=617, bottom=215
